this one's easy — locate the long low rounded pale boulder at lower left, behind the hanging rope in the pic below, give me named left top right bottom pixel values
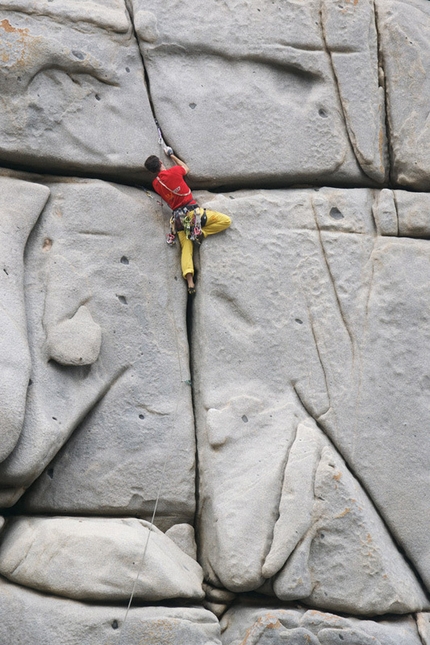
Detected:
left=0, top=517, right=204, bottom=602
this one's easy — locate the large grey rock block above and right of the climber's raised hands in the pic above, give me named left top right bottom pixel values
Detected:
left=130, top=0, right=386, bottom=186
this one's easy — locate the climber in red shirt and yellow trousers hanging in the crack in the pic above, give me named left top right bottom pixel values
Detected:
left=145, top=146, right=231, bottom=295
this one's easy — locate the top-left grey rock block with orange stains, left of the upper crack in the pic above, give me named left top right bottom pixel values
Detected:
left=0, top=0, right=157, bottom=178
